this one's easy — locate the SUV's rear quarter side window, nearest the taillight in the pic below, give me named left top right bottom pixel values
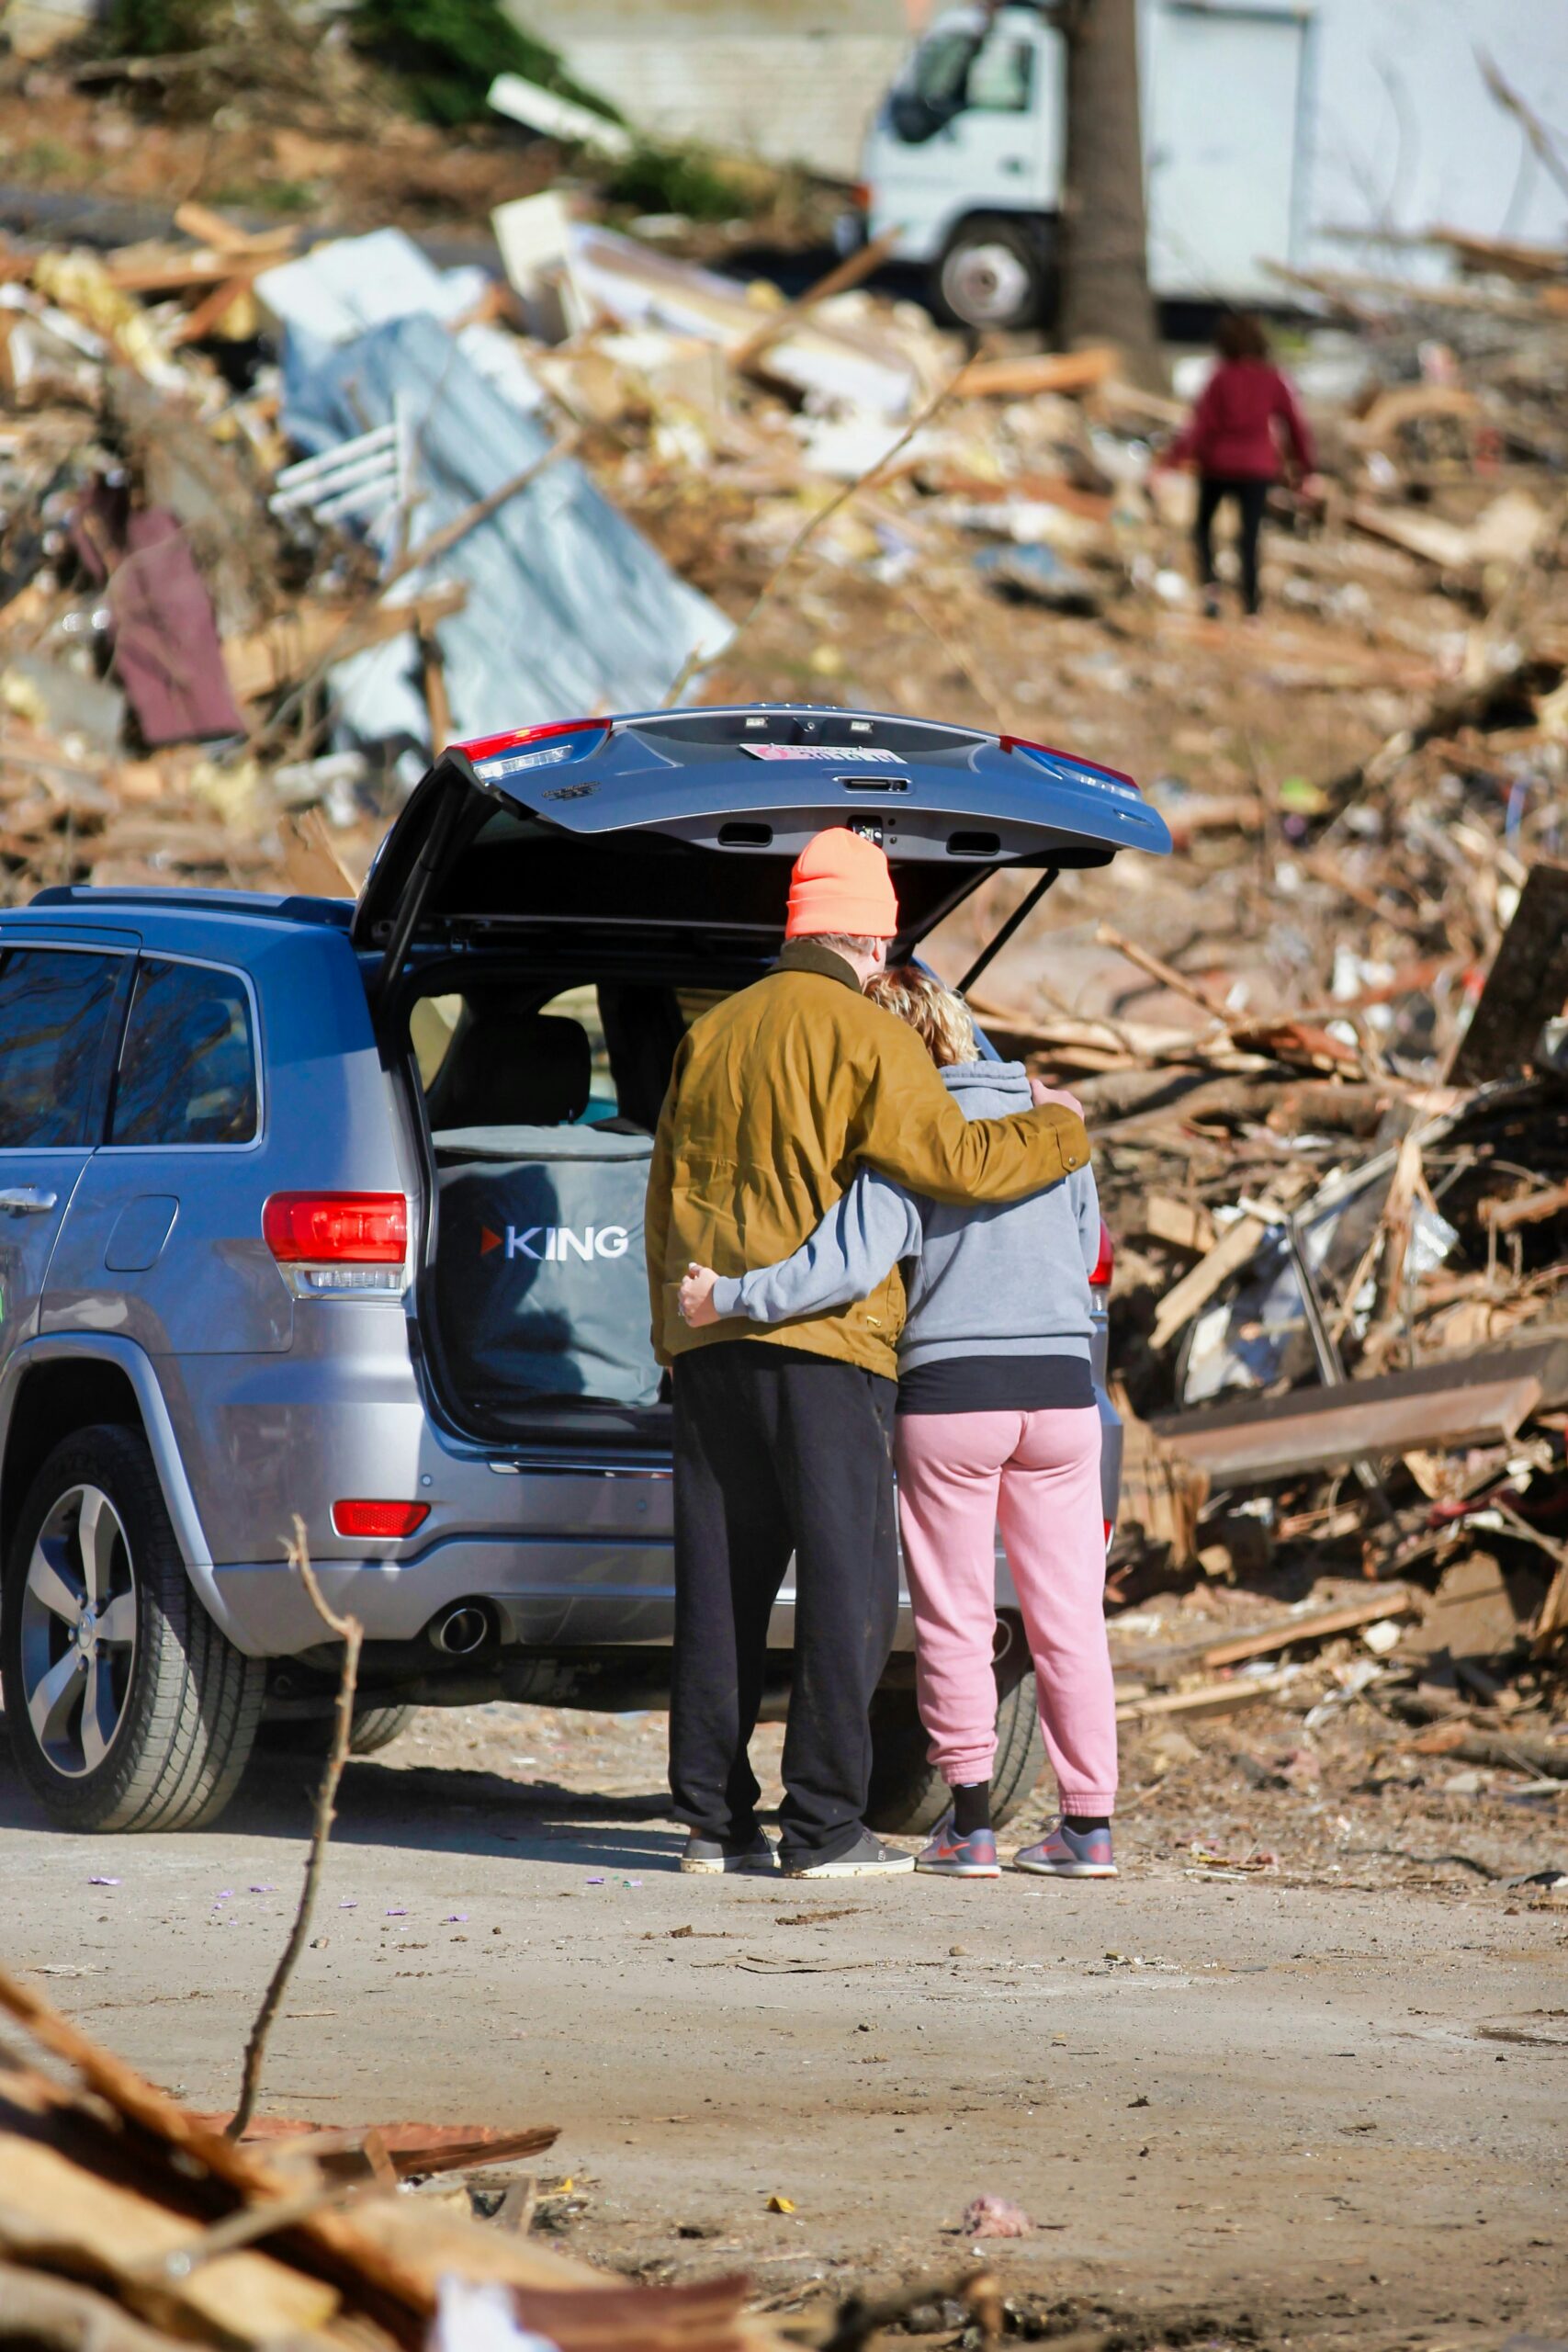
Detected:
left=108, top=962, right=256, bottom=1143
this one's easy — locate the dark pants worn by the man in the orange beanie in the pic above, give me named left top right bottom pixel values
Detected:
left=670, top=1340, right=898, bottom=1860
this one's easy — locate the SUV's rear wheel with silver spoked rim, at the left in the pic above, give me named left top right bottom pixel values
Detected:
left=0, top=1425, right=265, bottom=1830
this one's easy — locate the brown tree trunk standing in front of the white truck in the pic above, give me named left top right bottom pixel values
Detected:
left=1060, top=0, right=1166, bottom=388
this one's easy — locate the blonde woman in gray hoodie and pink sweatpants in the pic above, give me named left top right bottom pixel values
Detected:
left=680, top=965, right=1117, bottom=1877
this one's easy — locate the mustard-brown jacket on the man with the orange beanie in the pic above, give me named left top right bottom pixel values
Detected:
left=647, top=938, right=1089, bottom=1378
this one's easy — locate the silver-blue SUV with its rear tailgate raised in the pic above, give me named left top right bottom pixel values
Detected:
left=0, top=708, right=1168, bottom=1832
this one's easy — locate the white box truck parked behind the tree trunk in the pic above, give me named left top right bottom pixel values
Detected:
left=841, top=0, right=1316, bottom=329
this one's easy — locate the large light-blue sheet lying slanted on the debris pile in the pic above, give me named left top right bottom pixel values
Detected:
left=282, top=315, right=731, bottom=783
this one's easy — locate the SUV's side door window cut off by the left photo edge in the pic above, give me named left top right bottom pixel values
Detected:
left=0, top=948, right=122, bottom=1150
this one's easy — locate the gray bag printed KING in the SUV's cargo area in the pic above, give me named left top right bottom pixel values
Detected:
left=434, top=1126, right=659, bottom=1404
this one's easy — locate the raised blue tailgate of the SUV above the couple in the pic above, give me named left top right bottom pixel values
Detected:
left=353, top=706, right=1170, bottom=988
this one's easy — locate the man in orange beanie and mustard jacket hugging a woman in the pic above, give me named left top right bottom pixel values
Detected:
left=647, top=826, right=1089, bottom=1877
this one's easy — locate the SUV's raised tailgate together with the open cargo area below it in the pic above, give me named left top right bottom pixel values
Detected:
left=373, top=708, right=1170, bottom=1453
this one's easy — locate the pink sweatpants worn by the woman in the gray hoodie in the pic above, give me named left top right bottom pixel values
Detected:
left=896, top=1407, right=1117, bottom=1814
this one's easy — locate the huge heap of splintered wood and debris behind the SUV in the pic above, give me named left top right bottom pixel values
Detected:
left=0, top=114, right=1568, bottom=1796
